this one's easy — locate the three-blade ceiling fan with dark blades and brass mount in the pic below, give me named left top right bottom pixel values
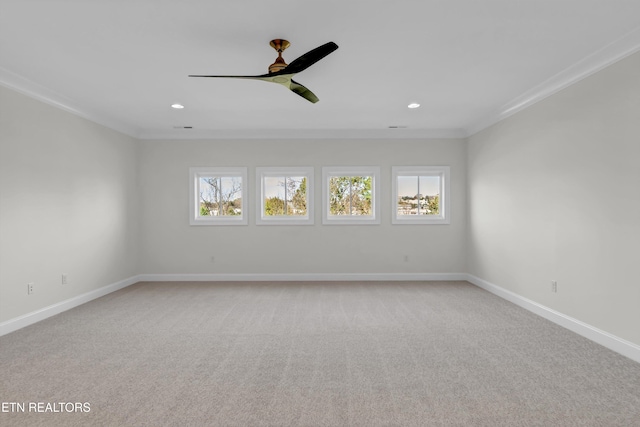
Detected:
left=189, top=39, right=338, bottom=103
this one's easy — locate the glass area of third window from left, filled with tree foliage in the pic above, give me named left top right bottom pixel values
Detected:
left=329, top=176, right=373, bottom=216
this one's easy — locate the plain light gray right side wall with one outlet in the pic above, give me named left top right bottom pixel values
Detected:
left=468, top=50, right=640, bottom=344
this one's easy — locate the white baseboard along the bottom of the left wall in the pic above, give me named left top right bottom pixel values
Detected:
left=0, top=276, right=140, bottom=336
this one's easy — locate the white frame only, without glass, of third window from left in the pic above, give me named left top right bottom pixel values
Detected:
left=322, top=166, right=381, bottom=225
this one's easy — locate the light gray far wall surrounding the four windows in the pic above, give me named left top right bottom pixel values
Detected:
left=140, top=140, right=467, bottom=274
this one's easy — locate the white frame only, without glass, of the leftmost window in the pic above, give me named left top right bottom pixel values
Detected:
left=189, top=167, right=249, bottom=225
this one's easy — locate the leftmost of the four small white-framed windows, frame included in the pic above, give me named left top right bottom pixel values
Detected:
left=189, top=168, right=247, bottom=225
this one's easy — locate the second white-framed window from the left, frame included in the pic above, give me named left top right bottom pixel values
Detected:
left=256, top=167, right=313, bottom=225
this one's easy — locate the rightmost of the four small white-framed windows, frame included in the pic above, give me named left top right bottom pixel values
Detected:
left=391, top=166, right=450, bottom=224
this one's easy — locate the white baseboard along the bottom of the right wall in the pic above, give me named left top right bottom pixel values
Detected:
left=467, top=274, right=640, bottom=363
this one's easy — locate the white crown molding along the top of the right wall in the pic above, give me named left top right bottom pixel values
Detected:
left=466, top=27, right=640, bottom=137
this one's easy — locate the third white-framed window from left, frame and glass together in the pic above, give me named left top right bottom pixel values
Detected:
left=322, top=166, right=380, bottom=224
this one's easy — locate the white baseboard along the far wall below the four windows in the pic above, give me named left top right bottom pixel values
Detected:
left=138, top=273, right=467, bottom=282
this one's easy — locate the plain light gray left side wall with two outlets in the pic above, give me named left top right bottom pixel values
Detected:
left=0, top=86, right=138, bottom=323
